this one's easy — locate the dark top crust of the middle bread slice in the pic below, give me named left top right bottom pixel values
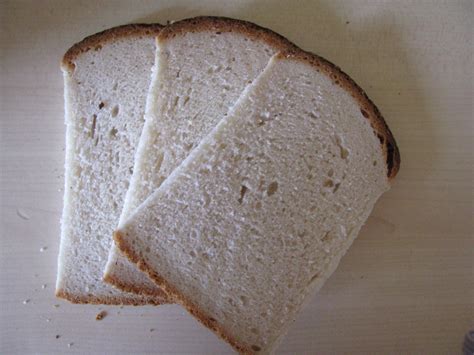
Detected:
left=157, top=16, right=296, bottom=50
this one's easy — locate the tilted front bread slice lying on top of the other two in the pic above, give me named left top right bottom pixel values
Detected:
left=115, top=50, right=400, bottom=354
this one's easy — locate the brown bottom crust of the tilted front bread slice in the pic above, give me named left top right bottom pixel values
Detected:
left=114, top=231, right=255, bottom=354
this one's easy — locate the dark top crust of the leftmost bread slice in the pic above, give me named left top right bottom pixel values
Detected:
left=61, top=23, right=163, bottom=71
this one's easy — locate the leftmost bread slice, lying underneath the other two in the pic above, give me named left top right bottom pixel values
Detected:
left=56, top=25, right=166, bottom=304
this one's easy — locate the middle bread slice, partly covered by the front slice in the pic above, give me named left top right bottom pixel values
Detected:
left=104, top=17, right=293, bottom=292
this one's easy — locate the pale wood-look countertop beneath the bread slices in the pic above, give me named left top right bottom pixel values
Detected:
left=0, top=0, right=474, bottom=354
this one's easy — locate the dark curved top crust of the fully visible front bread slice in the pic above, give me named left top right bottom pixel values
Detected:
left=277, top=48, right=400, bottom=180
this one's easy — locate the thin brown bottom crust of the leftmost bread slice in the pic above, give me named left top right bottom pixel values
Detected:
left=56, top=290, right=164, bottom=306
